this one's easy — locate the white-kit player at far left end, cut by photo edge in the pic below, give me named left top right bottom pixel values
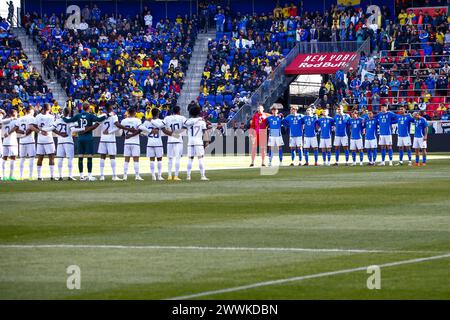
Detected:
left=1, top=109, right=18, bottom=180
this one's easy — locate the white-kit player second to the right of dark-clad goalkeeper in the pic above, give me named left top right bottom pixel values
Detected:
left=120, top=108, right=144, bottom=180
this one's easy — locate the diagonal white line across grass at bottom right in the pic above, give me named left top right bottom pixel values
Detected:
left=168, top=253, right=450, bottom=300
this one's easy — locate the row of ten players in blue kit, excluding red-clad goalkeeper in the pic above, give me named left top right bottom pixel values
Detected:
left=266, top=105, right=428, bottom=166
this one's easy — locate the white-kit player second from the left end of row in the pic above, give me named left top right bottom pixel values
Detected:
left=17, top=105, right=37, bottom=180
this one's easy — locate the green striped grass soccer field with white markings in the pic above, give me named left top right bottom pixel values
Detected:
left=0, top=154, right=450, bottom=299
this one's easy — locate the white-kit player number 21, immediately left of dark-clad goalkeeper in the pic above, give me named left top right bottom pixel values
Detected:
left=42, top=108, right=84, bottom=181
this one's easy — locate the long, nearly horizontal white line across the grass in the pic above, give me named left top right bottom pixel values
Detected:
left=0, top=244, right=438, bottom=253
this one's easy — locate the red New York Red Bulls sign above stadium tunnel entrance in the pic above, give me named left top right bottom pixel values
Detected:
left=285, top=52, right=359, bottom=74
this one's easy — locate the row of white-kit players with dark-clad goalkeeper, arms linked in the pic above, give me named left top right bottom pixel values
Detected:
left=0, top=104, right=208, bottom=181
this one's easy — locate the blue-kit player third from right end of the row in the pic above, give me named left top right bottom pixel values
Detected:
left=377, top=104, right=397, bottom=166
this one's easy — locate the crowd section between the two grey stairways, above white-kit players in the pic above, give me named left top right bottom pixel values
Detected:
left=22, top=4, right=198, bottom=117
